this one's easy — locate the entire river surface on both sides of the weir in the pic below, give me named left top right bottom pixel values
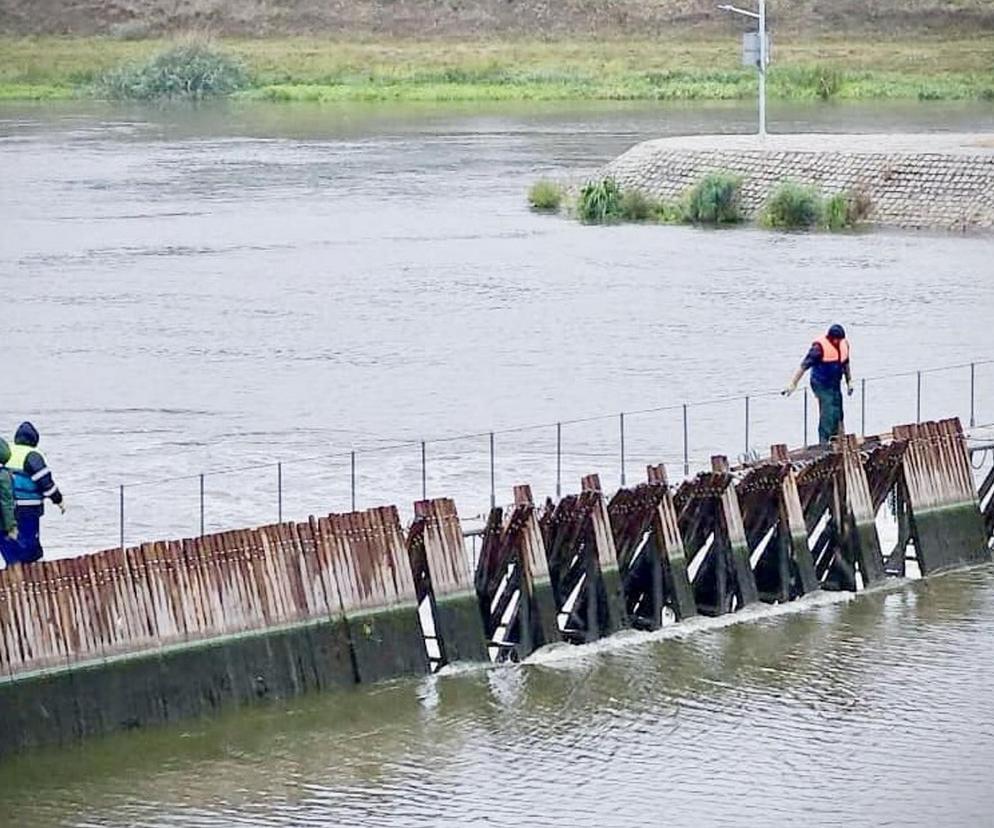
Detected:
left=0, top=104, right=994, bottom=828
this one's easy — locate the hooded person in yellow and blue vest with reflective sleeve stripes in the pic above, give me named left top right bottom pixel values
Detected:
left=7, top=423, right=66, bottom=563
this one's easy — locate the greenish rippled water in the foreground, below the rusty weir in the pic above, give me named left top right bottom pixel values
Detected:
left=0, top=567, right=994, bottom=826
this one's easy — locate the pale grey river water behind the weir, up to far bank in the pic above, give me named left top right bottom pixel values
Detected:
left=0, top=104, right=994, bottom=555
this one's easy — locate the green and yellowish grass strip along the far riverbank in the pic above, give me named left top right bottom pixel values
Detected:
left=0, top=34, right=994, bottom=102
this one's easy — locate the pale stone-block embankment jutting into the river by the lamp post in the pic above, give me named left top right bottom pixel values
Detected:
left=604, top=134, right=994, bottom=230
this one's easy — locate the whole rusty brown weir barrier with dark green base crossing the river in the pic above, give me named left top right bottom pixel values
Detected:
left=0, top=420, right=994, bottom=755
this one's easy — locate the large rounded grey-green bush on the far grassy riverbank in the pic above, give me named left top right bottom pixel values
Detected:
left=97, top=43, right=249, bottom=101
